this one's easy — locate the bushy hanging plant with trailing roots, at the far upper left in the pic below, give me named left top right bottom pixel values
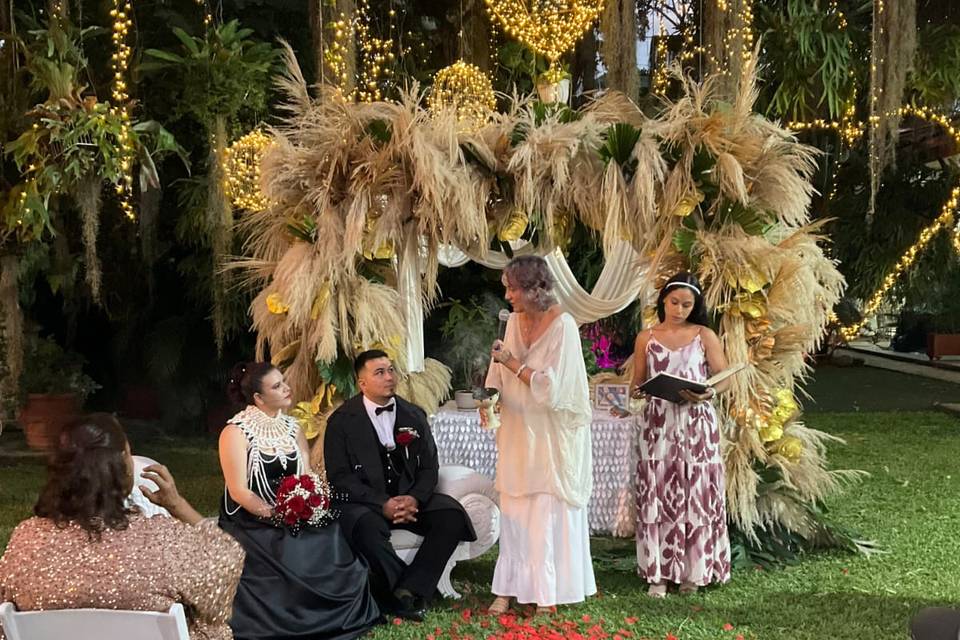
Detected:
left=0, top=17, right=182, bottom=301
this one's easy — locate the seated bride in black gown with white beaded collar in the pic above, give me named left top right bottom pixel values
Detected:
left=220, top=362, right=381, bottom=640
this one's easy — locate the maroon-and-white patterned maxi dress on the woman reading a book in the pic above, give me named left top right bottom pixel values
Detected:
left=637, top=333, right=730, bottom=586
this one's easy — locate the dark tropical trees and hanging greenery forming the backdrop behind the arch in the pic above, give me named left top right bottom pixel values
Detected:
left=0, top=0, right=960, bottom=560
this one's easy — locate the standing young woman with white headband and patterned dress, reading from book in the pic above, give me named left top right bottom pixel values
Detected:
left=631, top=273, right=730, bottom=598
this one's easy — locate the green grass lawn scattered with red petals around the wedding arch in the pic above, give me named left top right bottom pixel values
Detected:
left=0, top=370, right=960, bottom=640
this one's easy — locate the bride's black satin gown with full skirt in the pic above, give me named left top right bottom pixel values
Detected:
left=220, top=454, right=381, bottom=640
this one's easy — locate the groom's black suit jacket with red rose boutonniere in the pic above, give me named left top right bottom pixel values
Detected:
left=323, top=394, right=477, bottom=541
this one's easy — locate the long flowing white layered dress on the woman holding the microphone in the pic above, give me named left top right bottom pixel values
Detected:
left=486, top=313, right=597, bottom=606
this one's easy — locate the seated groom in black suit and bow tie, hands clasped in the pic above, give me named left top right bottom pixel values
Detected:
left=323, top=350, right=476, bottom=620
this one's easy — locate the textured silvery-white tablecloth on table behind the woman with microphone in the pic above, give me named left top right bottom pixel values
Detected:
left=433, top=408, right=637, bottom=538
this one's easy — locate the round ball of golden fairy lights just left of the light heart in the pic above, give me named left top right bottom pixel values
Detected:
left=427, top=60, right=497, bottom=128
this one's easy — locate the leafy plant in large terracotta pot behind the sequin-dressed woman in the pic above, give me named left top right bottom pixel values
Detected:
left=19, top=334, right=100, bottom=451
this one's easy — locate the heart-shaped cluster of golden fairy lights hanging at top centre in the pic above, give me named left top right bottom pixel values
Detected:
left=485, top=0, right=604, bottom=66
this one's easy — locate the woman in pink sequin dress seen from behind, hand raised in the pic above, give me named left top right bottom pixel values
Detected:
left=0, top=413, right=243, bottom=640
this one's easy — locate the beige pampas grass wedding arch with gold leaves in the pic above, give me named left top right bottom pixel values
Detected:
left=238, top=46, right=855, bottom=543
